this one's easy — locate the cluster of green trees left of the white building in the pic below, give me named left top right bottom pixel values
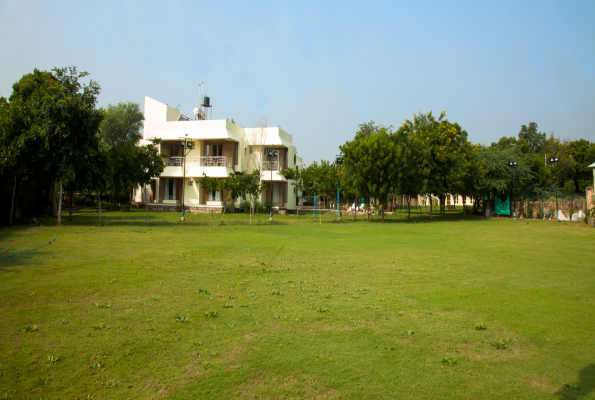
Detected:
left=0, top=67, right=165, bottom=223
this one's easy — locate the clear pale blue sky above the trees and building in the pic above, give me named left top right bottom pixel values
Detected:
left=0, top=0, right=595, bottom=163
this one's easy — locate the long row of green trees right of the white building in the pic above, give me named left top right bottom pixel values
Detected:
left=282, top=112, right=595, bottom=220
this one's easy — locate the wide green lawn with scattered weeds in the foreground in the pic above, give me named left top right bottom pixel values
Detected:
left=0, top=211, right=595, bottom=399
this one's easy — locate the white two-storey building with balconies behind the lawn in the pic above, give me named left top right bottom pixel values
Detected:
left=135, top=97, right=303, bottom=212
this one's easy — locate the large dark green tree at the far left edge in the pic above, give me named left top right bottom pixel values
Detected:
left=2, top=67, right=103, bottom=224
